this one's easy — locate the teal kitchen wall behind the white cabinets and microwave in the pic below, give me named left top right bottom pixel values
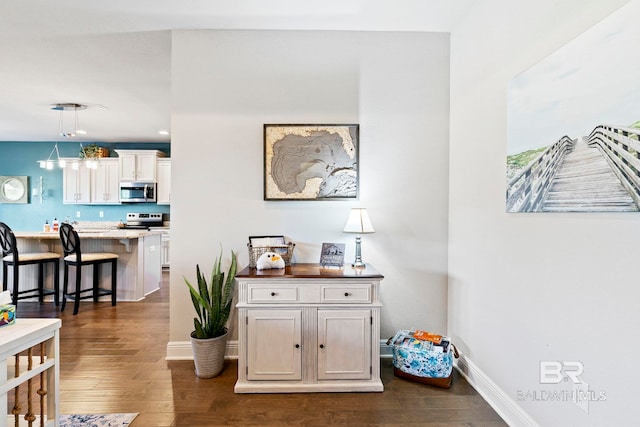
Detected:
left=0, top=141, right=171, bottom=231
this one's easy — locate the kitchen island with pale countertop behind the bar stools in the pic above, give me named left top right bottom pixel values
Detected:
left=8, top=228, right=163, bottom=301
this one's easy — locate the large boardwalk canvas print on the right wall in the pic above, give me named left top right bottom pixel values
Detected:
left=506, top=0, right=640, bottom=212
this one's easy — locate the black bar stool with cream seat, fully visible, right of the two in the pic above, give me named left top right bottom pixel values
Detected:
left=60, top=224, right=118, bottom=315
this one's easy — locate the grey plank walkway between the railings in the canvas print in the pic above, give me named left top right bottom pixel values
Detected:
left=540, top=138, right=638, bottom=212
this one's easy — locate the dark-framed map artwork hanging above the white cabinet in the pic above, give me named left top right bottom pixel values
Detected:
left=264, top=124, right=359, bottom=200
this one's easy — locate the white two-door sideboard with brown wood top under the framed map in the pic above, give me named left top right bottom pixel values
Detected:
left=234, top=264, right=384, bottom=393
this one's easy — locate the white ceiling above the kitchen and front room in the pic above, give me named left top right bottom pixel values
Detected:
left=0, top=0, right=473, bottom=142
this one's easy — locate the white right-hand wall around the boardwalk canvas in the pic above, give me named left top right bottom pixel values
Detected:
left=449, top=0, right=640, bottom=426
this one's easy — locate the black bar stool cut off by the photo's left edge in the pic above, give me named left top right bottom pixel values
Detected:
left=0, top=222, right=60, bottom=306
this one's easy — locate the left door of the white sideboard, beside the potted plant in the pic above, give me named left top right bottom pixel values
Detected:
left=247, top=309, right=302, bottom=380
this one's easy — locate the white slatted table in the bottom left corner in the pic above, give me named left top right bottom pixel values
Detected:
left=0, top=319, right=62, bottom=427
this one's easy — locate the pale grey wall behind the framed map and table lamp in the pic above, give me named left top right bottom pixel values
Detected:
left=170, top=31, right=449, bottom=348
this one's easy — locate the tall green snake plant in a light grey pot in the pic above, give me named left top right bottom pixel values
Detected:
left=184, top=250, right=238, bottom=378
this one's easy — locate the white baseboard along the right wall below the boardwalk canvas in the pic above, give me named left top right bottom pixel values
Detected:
left=456, top=354, right=540, bottom=427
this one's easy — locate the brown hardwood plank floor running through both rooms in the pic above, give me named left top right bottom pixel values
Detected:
left=12, top=272, right=506, bottom=427
